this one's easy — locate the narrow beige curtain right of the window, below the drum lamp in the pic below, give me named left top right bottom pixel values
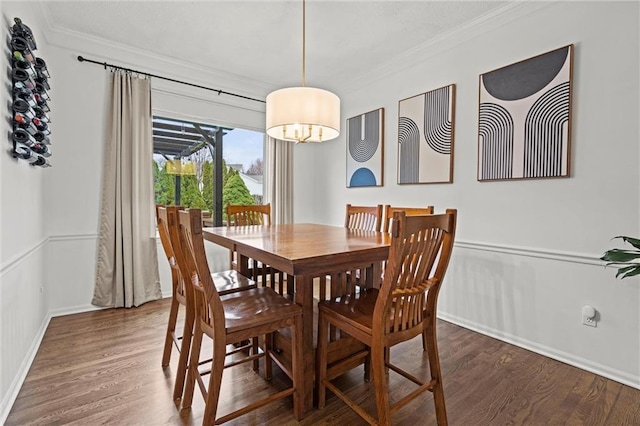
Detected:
left=264, top=135, right=293, bottom=223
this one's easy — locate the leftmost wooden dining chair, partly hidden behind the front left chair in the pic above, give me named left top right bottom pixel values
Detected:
left=156, top=205, right=257, bottom=399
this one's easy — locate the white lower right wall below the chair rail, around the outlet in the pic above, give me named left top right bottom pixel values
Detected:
left=438, top=242, right=640, bottom=389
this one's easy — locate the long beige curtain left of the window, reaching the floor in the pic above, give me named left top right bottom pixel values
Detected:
left=91, top=71, right=162, bottom=308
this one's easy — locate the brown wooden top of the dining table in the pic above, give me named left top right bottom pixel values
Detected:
left=203, top=223, right=391, bottom=275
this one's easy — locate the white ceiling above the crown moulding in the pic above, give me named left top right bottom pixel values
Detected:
left=38, top=0, right=513, bottom=95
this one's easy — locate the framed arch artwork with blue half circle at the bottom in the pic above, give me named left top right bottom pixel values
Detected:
left=347, top=108, right=384, bottom=188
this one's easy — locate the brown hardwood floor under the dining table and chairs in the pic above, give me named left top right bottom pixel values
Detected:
left=6, top=299, right=640, bottom=426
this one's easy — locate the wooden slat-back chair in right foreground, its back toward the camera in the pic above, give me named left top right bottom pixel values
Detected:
left=316, top=209, right=457, bottom=425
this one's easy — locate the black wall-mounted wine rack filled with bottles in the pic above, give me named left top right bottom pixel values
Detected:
left=9, top=18, right=51, bottom=167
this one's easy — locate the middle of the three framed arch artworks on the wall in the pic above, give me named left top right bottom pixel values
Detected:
left=398, top=84, right=455, bottom=184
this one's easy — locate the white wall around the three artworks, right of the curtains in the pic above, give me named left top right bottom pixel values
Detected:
left=295, top=2, right=640, bottom=388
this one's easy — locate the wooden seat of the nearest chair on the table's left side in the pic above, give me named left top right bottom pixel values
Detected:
left=221, top=287, right=302, bottom=343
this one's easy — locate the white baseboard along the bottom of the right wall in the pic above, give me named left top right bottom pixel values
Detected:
left=438, top=312, right=640, bottom=390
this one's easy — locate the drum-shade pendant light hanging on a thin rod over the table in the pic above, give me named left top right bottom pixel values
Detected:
left=266, top=0, right=340, bottom=143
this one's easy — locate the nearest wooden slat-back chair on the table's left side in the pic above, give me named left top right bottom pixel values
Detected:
left=176, top=209, right=304, bottom=425
